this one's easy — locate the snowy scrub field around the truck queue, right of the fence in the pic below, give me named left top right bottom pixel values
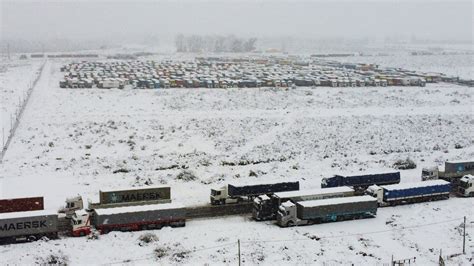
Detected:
left=0, top=61, right=474, bottom=265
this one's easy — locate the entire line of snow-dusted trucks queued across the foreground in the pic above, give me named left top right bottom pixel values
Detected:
left=0, top=161, right=474, bottom=243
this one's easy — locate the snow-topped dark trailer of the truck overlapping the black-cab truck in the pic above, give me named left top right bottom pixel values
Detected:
left=296, top=196, right=378, bottom=220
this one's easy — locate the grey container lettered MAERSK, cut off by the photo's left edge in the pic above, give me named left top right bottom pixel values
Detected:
left=0, top=210, right=59, bottom=244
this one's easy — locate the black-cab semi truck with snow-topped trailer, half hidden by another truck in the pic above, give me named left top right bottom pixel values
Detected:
left=252, top=187, right=354, bottom=221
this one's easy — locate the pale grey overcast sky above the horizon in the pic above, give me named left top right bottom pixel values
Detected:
left=0, top=0, right=474, bottom=40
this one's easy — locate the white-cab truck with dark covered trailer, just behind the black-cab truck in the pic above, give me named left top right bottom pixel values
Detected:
left=210, top=181, right=300, bottom=205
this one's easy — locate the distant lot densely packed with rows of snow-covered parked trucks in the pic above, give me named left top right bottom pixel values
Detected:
left=59, top=57, right=474, bottom=89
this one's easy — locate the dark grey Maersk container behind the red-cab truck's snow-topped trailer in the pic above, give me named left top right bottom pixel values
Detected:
left=99, top=187, right=171, bottom=204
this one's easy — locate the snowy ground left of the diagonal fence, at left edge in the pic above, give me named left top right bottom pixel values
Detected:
left=0, top=59, right=42, bottom=152
